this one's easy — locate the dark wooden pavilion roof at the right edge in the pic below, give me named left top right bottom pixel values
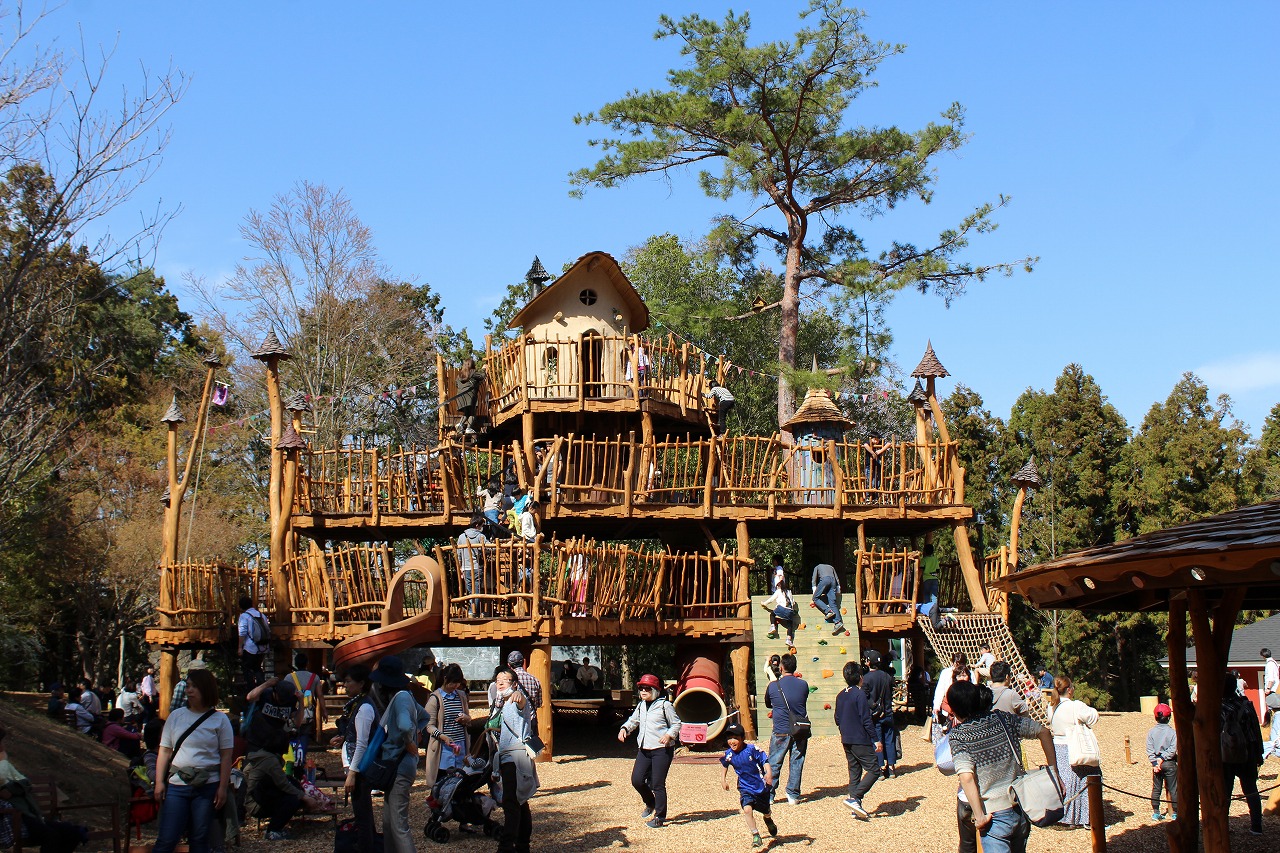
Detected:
left=995, top=501, right=1280, bottom=611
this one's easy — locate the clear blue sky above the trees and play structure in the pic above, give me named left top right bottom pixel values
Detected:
left=45, top=0, right=1280, bottom=434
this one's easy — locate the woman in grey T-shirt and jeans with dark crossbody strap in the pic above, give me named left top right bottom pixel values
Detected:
left=155, top=669, right=236, bottom=853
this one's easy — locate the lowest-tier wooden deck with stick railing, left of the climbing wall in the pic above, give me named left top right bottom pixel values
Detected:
left=147, top=537, right=751, bottom=646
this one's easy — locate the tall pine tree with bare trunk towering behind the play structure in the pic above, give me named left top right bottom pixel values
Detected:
left=570, top=0, right=1033, bottom=423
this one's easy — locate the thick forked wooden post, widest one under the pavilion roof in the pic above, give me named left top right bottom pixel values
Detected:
left=1179, top=587, right=1245, bottom=853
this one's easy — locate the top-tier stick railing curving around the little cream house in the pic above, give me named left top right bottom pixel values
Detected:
left=436, top=334, right=719, bottom=428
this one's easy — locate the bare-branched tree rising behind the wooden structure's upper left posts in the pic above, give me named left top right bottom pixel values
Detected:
left=197, top=181, right=453, bottom=443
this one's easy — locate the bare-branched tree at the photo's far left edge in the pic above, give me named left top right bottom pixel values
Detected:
left=0, top=3, right=187, bottom=540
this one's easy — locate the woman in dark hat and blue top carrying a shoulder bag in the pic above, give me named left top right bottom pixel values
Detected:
left=344, top=654, right=426, bottom=853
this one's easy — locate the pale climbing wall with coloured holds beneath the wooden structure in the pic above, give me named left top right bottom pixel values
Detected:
left=751, top=596, right=861, bottom=743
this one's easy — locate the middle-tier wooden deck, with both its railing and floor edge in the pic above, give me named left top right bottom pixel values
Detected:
left=293, top=433, right=973, bottom=539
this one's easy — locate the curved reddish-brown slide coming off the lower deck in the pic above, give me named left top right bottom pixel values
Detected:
left=333, top=555, right=444, bottom=671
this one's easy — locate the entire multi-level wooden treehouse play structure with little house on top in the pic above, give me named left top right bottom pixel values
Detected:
left=147, top=252, right=1036, bottom=744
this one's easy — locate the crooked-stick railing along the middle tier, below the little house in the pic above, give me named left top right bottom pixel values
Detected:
left=297, top=433, right=957, bottom=524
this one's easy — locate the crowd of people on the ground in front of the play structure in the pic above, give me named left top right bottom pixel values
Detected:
left=0, top=617, right=1280, bottom=853
